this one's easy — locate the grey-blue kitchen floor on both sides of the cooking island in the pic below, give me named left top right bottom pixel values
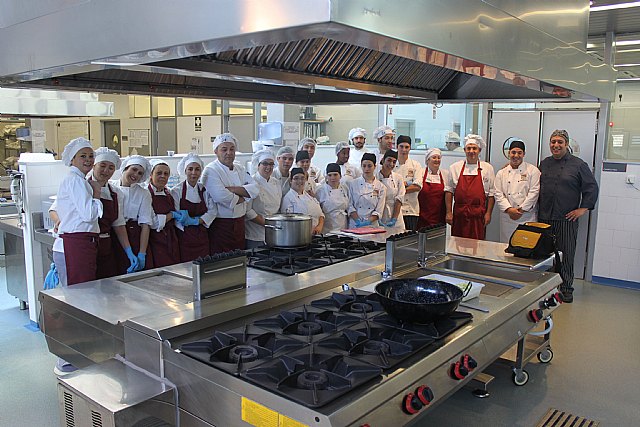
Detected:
left=0, top=271, right=640, bottom=427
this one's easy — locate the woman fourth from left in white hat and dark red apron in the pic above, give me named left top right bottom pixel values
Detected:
left=147, top=159, right=180, bottom=268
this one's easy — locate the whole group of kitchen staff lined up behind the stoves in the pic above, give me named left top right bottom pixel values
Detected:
left=50, top=126, right=598, bottom=299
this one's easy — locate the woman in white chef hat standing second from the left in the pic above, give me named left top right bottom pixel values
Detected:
left=88, top=147, right=138, bottom=279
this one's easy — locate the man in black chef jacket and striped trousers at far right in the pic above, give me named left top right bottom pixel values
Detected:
left=538, top=130, right=598, bottom=302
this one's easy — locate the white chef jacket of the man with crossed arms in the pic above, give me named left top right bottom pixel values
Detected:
left=202, top=159, right=260, bottom=218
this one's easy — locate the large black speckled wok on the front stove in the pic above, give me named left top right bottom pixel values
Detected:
left=376, top=279, right=471, bottom=323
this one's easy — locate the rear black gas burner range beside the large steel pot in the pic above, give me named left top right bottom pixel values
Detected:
left=247, top=235, right=386, bottom=276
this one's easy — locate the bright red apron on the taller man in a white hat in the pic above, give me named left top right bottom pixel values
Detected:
left=451, top=162, right=487, bottom=240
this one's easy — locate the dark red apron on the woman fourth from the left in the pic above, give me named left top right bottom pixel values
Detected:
left=147, top=185, right=180, bottom=268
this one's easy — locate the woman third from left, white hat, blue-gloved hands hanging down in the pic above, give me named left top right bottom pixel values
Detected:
left=110, top=155, right=153, bottom=274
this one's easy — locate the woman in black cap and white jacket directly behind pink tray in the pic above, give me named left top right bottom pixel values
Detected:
left=349, top=153, right=387, bottom=228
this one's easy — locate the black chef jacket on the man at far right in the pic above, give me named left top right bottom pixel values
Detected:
left=538, top=153, right=598, bottom=219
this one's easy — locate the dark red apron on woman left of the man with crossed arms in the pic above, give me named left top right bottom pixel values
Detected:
left=177, top=181, right=209, bottom=262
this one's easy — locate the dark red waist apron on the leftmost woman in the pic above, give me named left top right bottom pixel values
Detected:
left=60, top=233, right=99, bottom=286
